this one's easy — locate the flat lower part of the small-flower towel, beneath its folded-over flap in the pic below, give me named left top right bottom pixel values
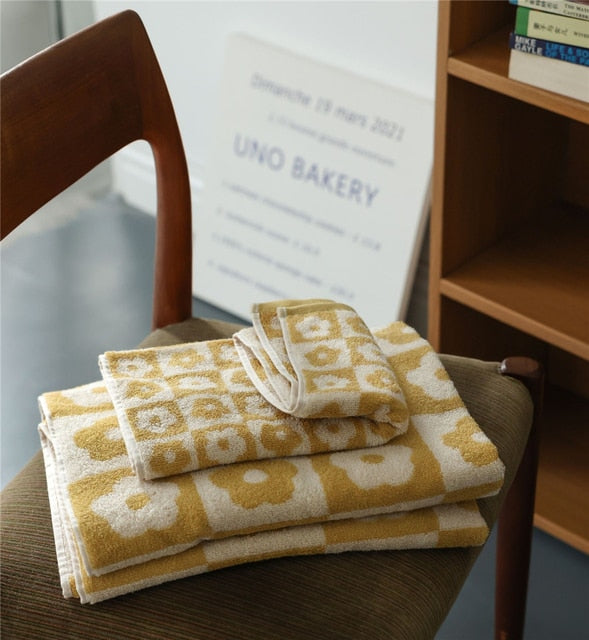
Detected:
left=97, top=330, right=408, bottom=480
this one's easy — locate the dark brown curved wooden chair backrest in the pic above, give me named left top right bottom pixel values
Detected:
left=0, top=11, right=192, bottom=328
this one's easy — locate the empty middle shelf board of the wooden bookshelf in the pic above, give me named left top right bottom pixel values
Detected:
left=440, top=209, right=589, bottom=360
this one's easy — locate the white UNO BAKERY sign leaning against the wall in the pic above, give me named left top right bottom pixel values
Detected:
left=193, top=35, right=433, bottom=326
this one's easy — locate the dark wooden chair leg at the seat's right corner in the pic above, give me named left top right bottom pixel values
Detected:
left=495, top=358, right=544, bottom=640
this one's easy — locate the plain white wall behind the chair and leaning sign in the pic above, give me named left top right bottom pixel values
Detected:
left=94, top=0, right=437, bottom=211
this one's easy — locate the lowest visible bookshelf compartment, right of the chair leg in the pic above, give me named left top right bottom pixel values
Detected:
left=534, top=387, right=589, bottom=553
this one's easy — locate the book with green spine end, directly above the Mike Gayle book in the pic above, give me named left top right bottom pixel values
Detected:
left=515, top=7, right=589, bottom=47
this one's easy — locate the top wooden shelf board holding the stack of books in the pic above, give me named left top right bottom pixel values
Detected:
left=447, top=25, right=589, bottom=124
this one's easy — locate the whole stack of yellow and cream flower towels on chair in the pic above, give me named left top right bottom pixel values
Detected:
left=39, top=300, right=504, bottom=603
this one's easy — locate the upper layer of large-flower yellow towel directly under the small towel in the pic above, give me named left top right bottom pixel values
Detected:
left=40, top=323, right=503, bottom=600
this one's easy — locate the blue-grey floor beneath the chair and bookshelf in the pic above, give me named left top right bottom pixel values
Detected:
left=0, top=196, right=589, bottom=640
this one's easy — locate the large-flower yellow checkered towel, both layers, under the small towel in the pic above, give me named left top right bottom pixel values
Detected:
left=40, top=323, right=503, bottom=602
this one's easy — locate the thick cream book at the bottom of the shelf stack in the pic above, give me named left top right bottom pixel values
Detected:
left=509, top=49, right=589, bottom=102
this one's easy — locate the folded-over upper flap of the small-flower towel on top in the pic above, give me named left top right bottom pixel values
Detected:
left=234, top=300, right=407, bottom=424
